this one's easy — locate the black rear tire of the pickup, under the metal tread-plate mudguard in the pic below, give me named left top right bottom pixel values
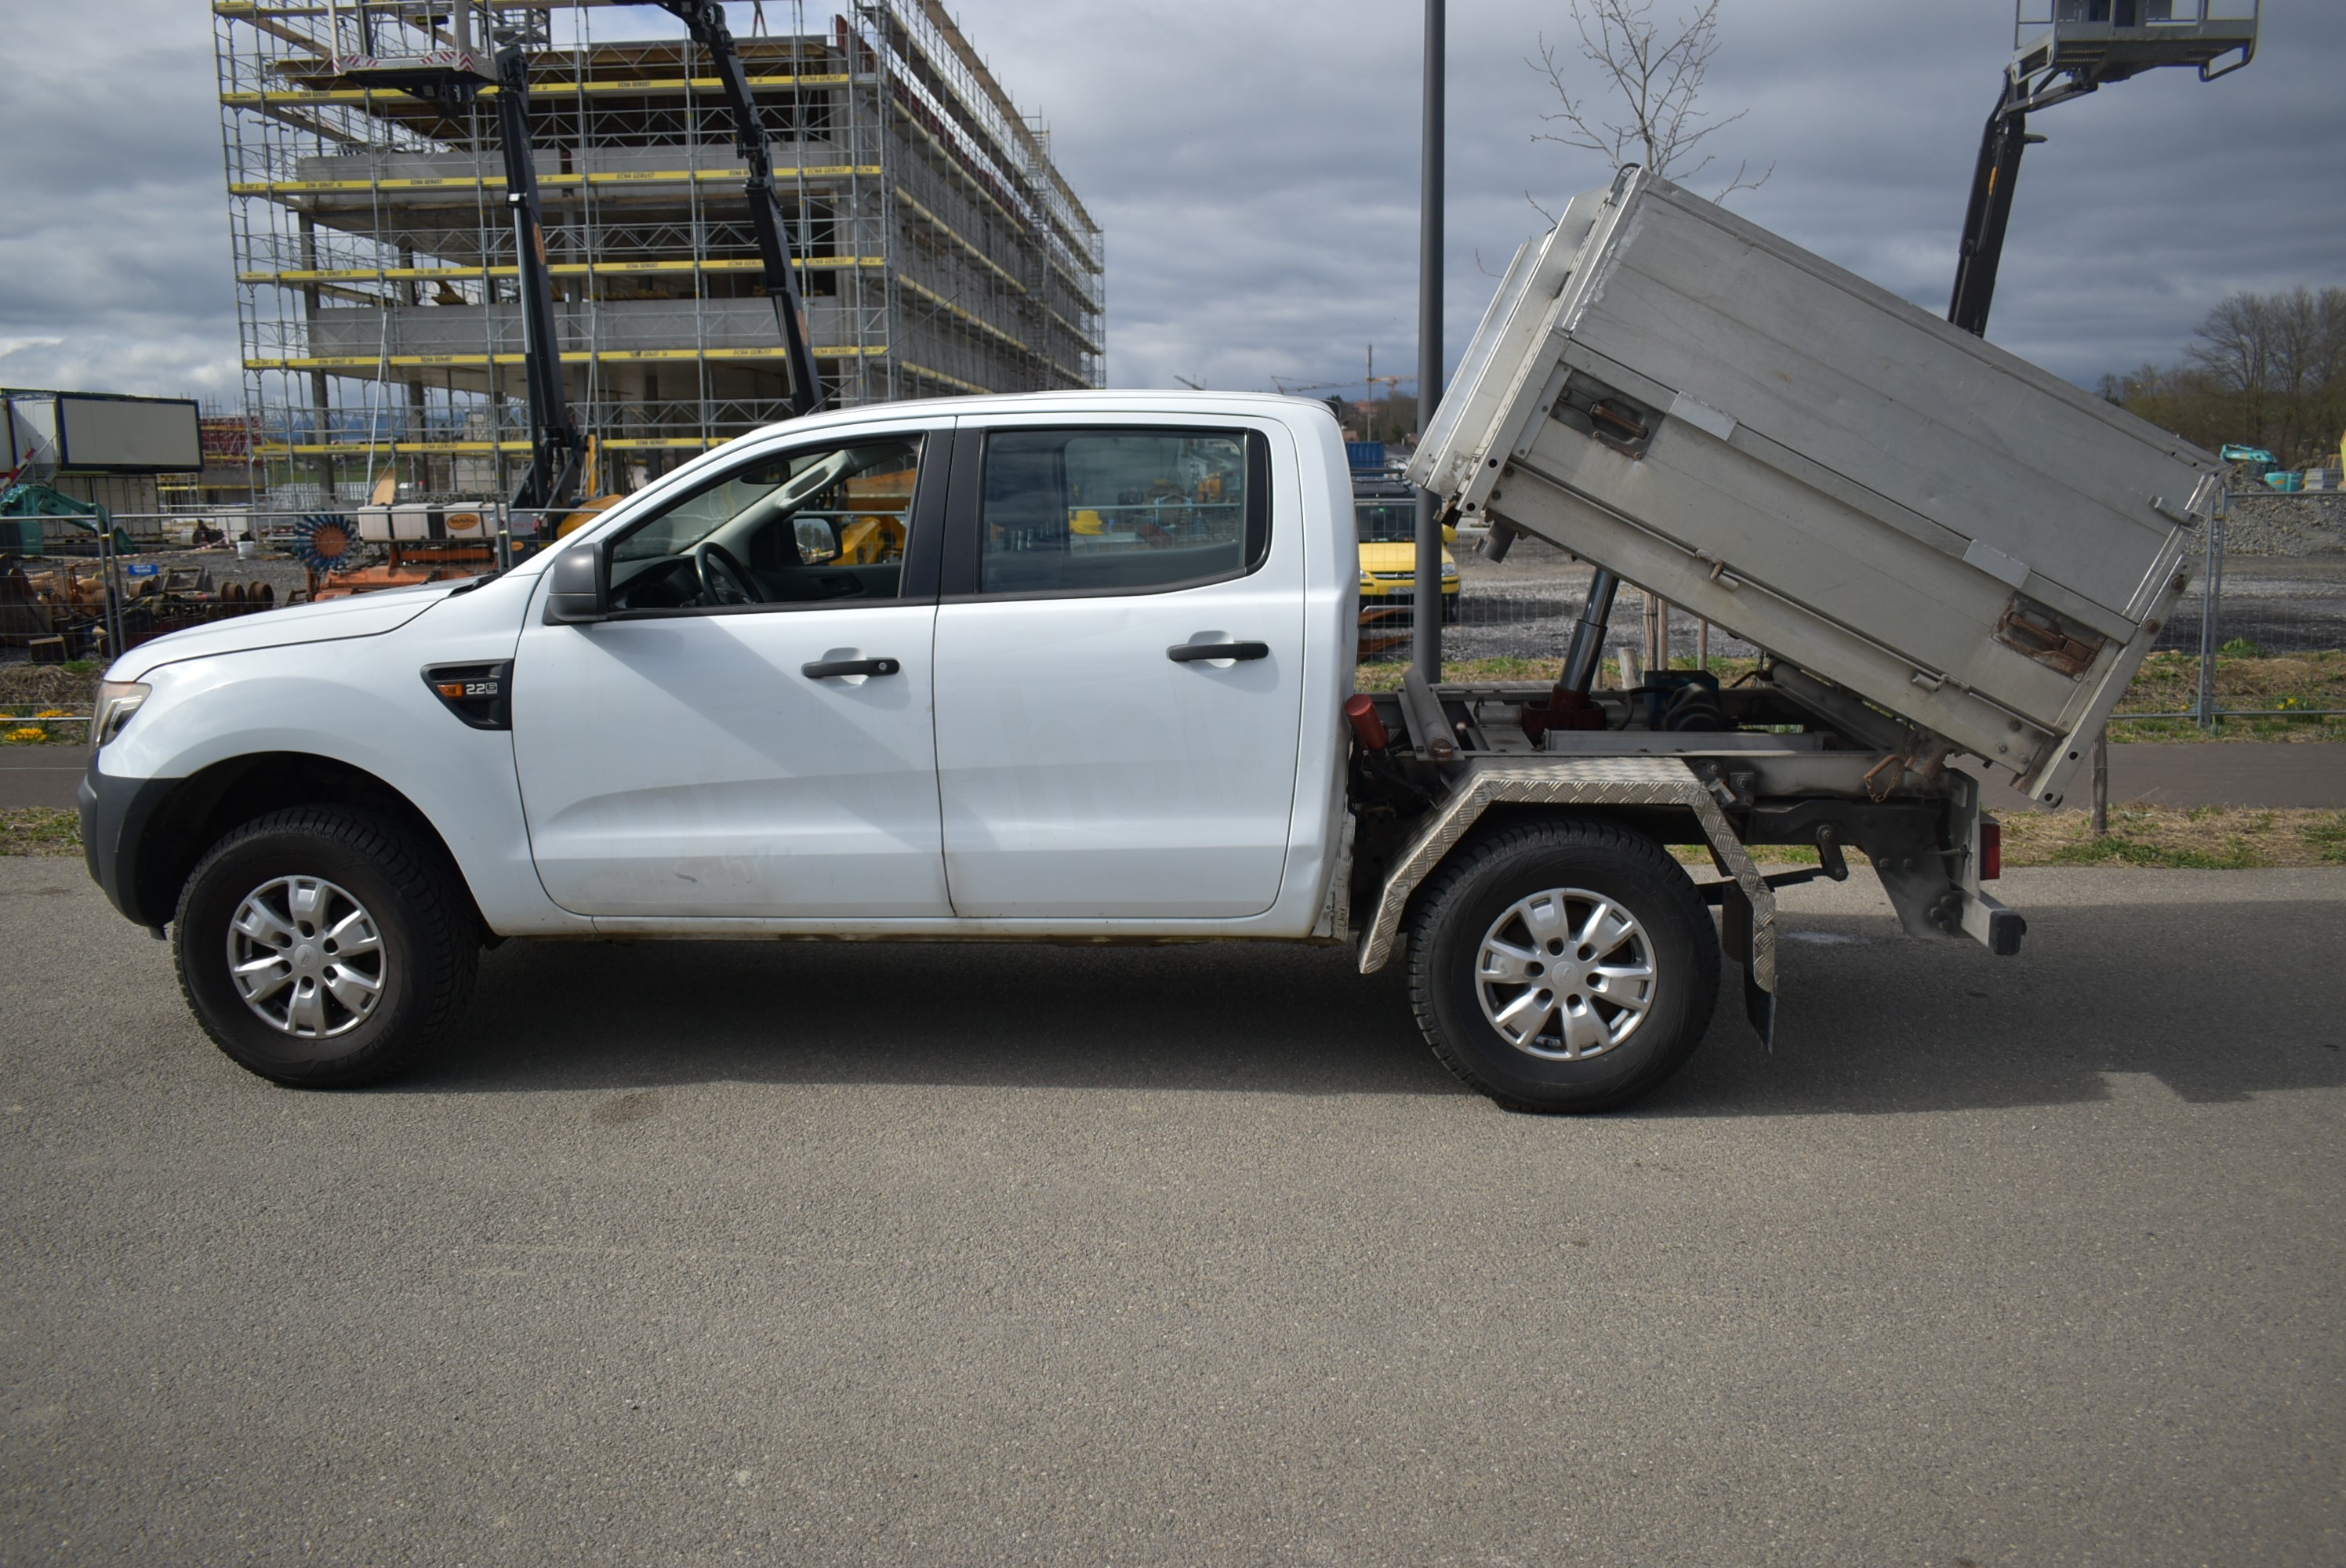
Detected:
left=1410, top=817, right=1720, bottom=1112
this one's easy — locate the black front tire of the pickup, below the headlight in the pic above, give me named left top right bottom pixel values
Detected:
left=171, top=805, right=481, bottom=1089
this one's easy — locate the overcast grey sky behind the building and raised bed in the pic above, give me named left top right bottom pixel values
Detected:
left=0, top=0, right=2346, bottom=401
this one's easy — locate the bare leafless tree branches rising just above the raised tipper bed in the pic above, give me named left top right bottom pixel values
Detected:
left=1525, top=0, right=1776, bottom=216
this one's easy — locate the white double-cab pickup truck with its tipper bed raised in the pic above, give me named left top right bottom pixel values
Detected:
left=82, top=176, right=2212, bottom=1110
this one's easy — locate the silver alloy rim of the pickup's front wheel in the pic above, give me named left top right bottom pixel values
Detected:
left=227, top=876, right=390, bottom=1040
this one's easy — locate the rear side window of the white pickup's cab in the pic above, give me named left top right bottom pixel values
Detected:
left=979, top=430, right=1272, bottom=593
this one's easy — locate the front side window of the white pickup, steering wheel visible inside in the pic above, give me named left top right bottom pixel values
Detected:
left=610, top=437, right=920, bottom=610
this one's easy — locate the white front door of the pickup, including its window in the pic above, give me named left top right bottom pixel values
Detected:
left=514, top=432, right=953, bottom=918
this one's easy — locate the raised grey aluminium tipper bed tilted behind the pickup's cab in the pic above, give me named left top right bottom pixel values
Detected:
left=1410, top=169, right=2221, bottom=803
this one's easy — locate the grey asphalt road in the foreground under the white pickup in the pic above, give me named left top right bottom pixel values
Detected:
left=0, top=859, right=2346, bottom=1568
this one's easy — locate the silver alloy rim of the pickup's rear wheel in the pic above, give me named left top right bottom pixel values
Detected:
left=1473, top=887, right=1654, bottom=1061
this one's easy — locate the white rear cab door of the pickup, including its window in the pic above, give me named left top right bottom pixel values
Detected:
left=936, top=416, right=1305, bottom=920
